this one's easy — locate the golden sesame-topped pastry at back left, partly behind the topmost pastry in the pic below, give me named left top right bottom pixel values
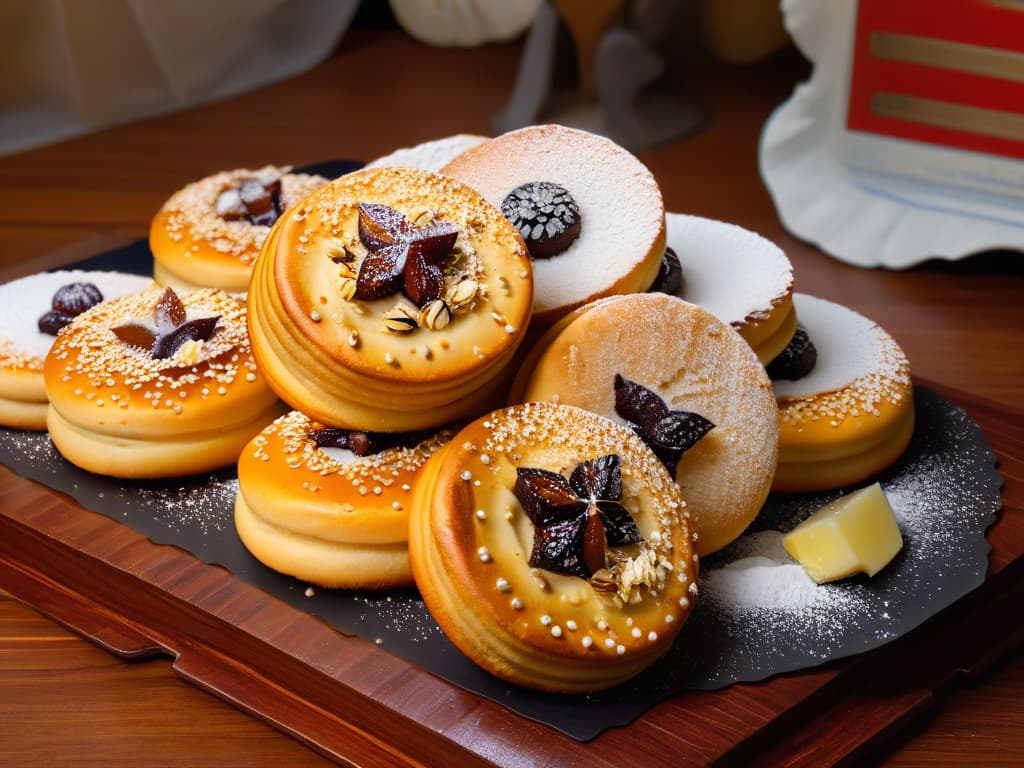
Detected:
left=150, top=166, right=327, bottom=293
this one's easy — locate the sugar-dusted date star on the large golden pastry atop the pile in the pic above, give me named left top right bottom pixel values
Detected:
left=355, top=203, right=459, bottom=308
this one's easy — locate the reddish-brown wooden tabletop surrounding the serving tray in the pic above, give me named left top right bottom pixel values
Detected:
left=0, top=30, right=1024, bottom=766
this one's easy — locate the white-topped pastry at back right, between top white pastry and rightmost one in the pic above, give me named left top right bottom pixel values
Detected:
left=666, top=213, right=797, bottom=364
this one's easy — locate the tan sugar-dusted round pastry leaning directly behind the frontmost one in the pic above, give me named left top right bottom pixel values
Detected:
left=510, top=293, right=778, bottom=557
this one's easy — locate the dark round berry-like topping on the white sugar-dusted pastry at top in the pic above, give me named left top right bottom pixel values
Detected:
left=501, top=181, right=581, bottom=259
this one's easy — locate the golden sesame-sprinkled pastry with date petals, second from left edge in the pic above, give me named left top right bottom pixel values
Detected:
left=43, top=288, right=281, bottom=478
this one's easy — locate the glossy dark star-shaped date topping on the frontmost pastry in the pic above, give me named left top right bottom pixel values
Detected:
left=512, top=454, right=643, bottom=579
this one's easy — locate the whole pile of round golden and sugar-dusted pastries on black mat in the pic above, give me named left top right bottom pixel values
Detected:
left=0, top=125, right=913, bottom=692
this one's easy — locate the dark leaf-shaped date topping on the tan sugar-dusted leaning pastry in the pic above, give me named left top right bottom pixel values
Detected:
left=615, top=374, right=715, bottom=477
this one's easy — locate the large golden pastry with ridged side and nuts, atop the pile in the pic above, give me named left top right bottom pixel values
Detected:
left=248, top=168, right=534, bottom=432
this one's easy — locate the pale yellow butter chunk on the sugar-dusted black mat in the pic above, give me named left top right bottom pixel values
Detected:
left=782, top=483, right=903, bottom=584
